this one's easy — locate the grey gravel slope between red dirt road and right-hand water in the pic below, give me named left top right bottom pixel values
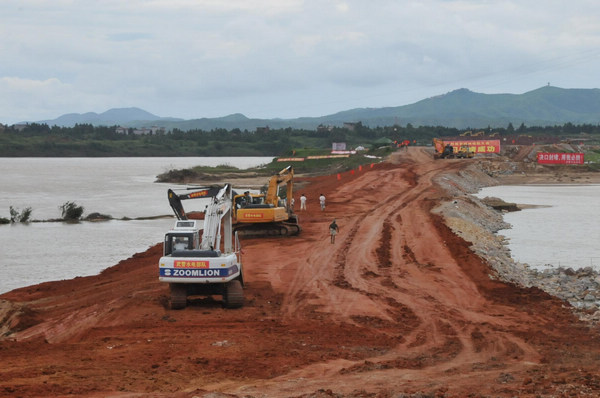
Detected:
left=434, top=161, right=600, bottom=324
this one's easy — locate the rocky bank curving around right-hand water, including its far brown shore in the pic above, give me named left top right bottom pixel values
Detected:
left=434, top=158, right=600, bottom=325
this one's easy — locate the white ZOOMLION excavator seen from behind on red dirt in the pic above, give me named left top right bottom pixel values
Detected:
left=158, top=184, right=244, bottom=309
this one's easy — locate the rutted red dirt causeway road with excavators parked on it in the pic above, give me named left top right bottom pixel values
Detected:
left=0, top=148, right=600, bottom=397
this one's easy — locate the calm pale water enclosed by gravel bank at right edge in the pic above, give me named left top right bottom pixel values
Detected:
left=476, top=184, right=600, bottom=271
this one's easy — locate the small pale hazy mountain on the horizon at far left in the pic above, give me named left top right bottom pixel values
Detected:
left=37, top=108, right=183, bottom=127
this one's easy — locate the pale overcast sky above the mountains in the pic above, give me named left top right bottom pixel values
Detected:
left=0, top=0, right=600, bottom=124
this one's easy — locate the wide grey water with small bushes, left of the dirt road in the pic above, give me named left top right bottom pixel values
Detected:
left=0, top=157, right=273, bottom=293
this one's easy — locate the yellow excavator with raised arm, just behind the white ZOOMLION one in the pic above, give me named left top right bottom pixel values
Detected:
left=233, top=166, right=301, bottom=236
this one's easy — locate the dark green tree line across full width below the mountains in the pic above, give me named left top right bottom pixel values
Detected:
left=0, top=122, right=600, bottom=157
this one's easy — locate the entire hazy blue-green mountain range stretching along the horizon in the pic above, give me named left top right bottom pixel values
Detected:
left=32, top=86, right=600, bottom=131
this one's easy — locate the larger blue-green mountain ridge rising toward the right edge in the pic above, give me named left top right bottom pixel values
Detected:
left=326, top=86, right=600, bottom=128
